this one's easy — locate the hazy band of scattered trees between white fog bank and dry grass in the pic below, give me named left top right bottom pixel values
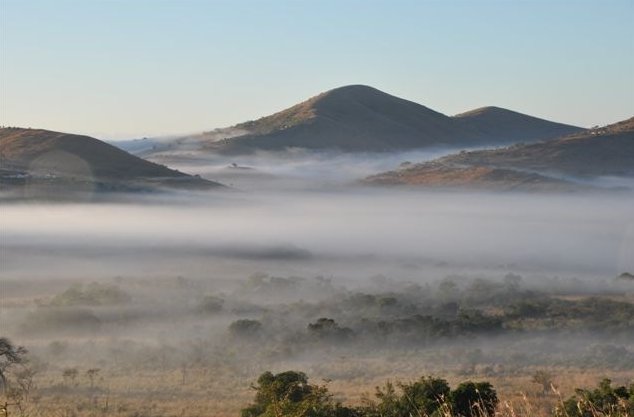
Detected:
left=12, top=274, right=634, bottom=375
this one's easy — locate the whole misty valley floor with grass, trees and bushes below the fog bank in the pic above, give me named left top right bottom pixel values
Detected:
left=0, top=274, right=634, bottom=417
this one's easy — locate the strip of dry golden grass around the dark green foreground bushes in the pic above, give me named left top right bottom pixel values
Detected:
left=3, top=358, right=634, bottom=417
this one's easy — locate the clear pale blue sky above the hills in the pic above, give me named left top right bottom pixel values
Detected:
left=0, top=0, right=634, bottom=139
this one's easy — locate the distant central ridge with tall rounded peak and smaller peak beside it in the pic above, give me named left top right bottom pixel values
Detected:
left=135, top=85, right=582, bottom=155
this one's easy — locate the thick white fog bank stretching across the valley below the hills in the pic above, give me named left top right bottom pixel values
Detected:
left=0, top=189, right=634, bottom=278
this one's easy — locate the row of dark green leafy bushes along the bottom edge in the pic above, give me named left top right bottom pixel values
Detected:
left=241, top=371, right=634, bottom=417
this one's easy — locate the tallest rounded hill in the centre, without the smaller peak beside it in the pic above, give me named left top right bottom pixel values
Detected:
left=205, top=85, right=466, bottom=151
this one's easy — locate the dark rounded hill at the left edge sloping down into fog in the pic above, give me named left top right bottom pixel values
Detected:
left=0, top=128, right=220, bottom=191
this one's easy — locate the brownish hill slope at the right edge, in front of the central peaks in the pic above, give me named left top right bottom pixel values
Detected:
left=364, top=117, right=634, bottom=190
